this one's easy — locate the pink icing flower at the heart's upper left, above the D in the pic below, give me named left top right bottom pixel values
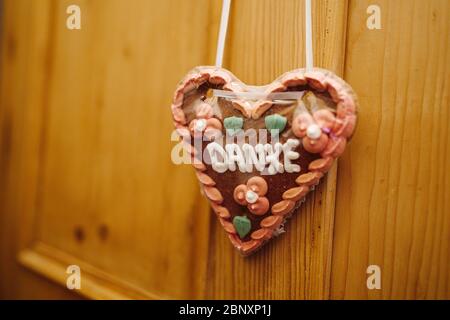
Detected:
left=189, top=103, right=222, bottom=139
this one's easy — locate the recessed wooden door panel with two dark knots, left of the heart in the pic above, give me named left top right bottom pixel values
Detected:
left=31, top=1, right=221, bottom=298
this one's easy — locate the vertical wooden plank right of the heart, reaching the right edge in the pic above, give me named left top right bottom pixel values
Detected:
left=331, top=0, right=450, bottom=299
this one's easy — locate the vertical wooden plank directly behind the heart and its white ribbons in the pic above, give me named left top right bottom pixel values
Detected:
left=207, top=0, right=347, bottom=299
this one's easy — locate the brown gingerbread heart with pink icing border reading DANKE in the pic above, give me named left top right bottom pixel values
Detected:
left=172, top=67, right=357, bottom=255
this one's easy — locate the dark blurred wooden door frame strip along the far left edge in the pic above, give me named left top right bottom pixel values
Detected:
left=0, top=1, right=78, bottom=299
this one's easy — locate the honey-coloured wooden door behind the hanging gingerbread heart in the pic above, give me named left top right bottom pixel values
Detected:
left=0, top=0, right=450, bottom=299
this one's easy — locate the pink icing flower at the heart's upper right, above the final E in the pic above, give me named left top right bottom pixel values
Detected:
left=292, top=109, right=336, bottom=153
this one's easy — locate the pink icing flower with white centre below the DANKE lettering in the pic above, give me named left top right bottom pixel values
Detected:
left=233, top=177, right=270, bottom=216
